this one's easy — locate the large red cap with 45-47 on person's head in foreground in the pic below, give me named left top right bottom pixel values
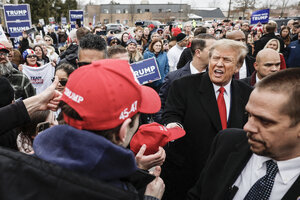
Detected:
left=61, top=59, right=161, bottom=130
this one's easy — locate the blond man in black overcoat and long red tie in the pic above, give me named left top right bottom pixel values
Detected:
left=162, top=39, right=252, bottom=200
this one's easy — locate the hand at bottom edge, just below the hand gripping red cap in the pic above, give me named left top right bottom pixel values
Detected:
left=145, top=166, right=165, bottom=199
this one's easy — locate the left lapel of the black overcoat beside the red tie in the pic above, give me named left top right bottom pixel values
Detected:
left=199, top=72, right=222, bottom=130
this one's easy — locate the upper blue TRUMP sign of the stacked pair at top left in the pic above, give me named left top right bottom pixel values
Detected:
left=3, top=4, right=31, bottom=22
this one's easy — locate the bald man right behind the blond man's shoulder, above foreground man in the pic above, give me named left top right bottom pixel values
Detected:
left=241, top=49, right=280, bottom=86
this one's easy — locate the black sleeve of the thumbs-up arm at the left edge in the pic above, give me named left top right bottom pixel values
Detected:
left=0, top=101, right=30, bottom=134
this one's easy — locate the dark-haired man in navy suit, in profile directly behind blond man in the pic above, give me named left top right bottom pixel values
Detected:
left=155, top=34, right=216, bottom=122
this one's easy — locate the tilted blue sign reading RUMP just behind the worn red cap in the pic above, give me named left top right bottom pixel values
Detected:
left=131, top=57, right=161, bottom=84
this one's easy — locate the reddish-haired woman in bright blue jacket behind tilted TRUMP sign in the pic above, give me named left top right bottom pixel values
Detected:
left=144, top=39, right=169, bottom=92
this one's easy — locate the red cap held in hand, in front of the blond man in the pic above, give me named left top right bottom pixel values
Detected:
left=130, top=122, right=185, bottom=155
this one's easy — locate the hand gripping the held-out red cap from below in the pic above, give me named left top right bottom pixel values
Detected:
left=135, top=144, right=166, bottom=170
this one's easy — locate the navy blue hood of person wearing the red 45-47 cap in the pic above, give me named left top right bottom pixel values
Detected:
left=33, top=125, right=137, bottom=189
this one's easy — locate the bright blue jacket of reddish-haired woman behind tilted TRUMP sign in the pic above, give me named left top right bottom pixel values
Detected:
left=144, top=50, right=169, bottom=87
